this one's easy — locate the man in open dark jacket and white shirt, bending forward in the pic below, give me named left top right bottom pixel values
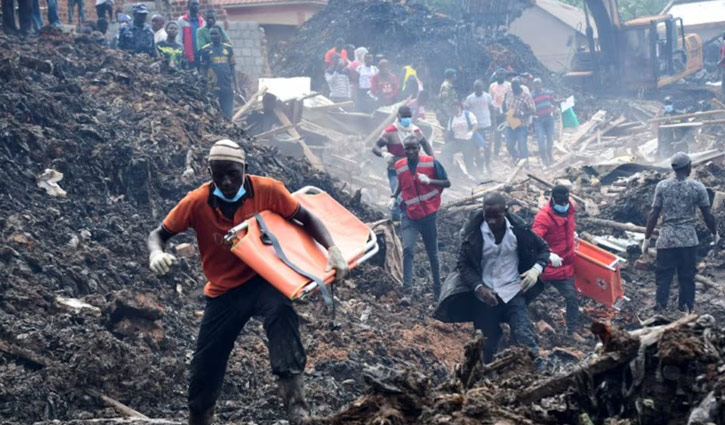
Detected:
left=434, top=193, right=550, bottom=368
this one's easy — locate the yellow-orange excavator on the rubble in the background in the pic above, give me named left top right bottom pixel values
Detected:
left=566, top=0, right=703, bottom=93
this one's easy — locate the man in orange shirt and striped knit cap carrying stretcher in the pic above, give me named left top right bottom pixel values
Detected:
left=148, top=140, right=348, bottom=425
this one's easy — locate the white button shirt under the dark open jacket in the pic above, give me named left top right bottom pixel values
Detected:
left=481, top=219, right=521, bottom=303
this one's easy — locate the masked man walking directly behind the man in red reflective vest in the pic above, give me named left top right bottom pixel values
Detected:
left=373, top=106, right=433, bottom=221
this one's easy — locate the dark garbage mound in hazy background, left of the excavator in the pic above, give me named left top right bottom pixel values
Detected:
left=271, top=0, right=550, bottom=92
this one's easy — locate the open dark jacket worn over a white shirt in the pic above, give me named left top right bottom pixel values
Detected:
left=433, top=209, right=549, bottom=322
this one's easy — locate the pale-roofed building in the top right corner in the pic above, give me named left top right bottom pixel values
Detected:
left=662, top=0, right=725, bottom=43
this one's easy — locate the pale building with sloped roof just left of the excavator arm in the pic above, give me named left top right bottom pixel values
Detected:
left=509, top=0, right=597, bottom=73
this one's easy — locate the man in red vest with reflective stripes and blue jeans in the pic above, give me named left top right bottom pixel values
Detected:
left=389, top=136, right=451, bottom=304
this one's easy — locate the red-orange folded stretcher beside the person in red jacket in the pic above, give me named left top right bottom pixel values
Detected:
left=574, top=239, right=624, bottom=308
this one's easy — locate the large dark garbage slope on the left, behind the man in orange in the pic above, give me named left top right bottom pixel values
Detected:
left=0, top=31, right=468, bottom=424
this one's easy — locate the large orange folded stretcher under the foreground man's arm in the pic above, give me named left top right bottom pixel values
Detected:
left=224, top=186, right=378, bottom=304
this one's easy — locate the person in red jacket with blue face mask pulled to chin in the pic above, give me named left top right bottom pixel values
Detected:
left=531, top=185, right=579, bottom=335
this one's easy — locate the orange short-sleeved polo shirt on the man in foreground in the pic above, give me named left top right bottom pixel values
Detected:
left=164, top=175, right=300, bottom=298
